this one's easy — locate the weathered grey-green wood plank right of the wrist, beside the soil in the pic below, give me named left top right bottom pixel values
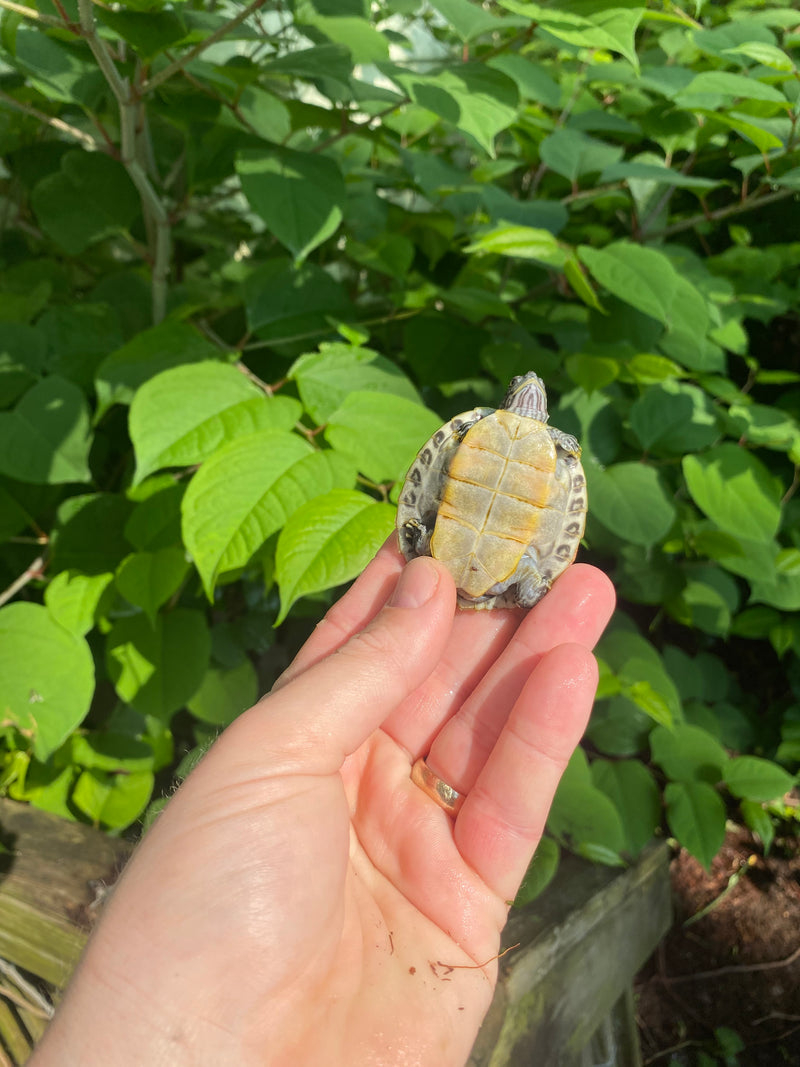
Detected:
left=469, top=844, right=672, bottom=1067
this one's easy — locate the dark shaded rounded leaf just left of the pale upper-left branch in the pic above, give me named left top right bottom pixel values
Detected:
left=31, top=149, right=141, bottom=256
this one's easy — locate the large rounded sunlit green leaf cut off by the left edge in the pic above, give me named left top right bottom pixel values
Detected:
left=0, top=602, right=95, bottom=761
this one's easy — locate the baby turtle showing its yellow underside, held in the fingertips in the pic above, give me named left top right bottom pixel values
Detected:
left=397, top=371, right=587, bottom=608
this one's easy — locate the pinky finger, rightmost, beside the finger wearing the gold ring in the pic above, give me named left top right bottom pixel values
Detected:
left=454, top=644, right=597, bottom=901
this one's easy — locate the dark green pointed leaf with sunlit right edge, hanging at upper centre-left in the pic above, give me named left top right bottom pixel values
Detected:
left=236, top=147, right=345, bottom=260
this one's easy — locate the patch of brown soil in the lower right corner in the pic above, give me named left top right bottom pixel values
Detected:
left=636, top=828, right=800, bottom=1067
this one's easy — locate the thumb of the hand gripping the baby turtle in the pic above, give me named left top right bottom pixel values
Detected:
left=227, top=556, right=455, bottom=774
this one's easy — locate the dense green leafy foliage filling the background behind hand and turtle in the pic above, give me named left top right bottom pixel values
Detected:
left=0, top=0, right=800, bottom=857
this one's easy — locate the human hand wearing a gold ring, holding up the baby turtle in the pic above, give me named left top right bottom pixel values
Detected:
left=31, top=542, right=613, bottom=1067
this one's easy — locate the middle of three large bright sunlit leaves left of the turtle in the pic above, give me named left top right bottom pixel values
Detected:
left=181, top=430, right=354, bottom=599
